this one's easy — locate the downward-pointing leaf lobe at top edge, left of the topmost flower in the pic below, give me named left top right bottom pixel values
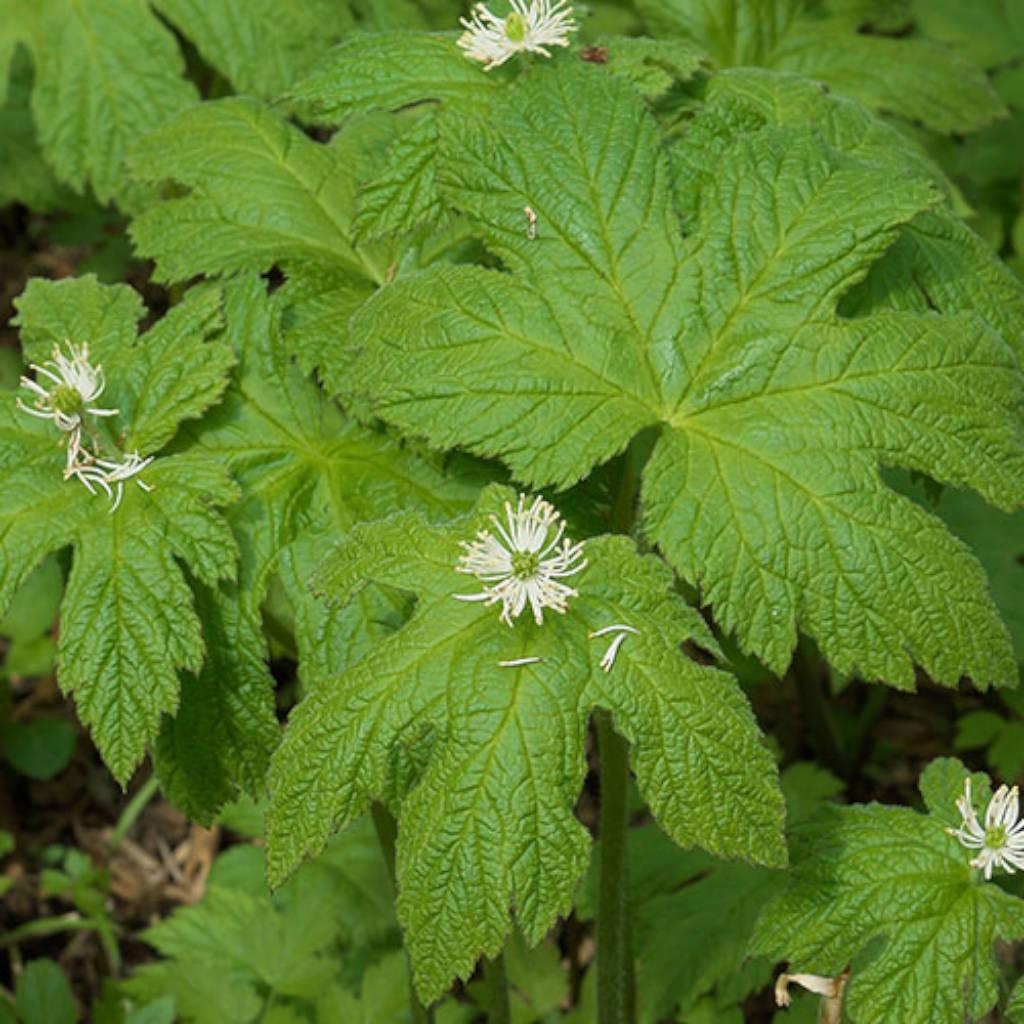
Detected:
left=156, top=0, right=354, bottom=99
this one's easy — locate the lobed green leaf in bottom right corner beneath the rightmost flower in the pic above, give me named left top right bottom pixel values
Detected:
left=754, top=761, right=1024, bottom=1024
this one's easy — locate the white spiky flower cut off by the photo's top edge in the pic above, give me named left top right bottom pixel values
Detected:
left=459, top=0, right=577, bottom=71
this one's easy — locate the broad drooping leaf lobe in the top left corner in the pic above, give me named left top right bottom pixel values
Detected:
left=19, top=0, right=198, bottom=203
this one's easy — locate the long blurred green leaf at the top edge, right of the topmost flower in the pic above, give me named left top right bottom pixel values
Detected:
left=637, top=0, right=1005, bottom=134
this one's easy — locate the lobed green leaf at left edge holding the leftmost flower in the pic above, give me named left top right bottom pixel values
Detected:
left=0, top=278, right=237, bottom=781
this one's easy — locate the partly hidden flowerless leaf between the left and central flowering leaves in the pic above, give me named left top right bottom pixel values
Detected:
left=188, top=278, right=476, bottom=676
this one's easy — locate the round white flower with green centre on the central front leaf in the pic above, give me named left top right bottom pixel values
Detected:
left=453, top=495, right=587, bottom=626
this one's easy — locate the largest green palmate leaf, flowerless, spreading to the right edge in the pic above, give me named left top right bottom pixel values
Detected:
left=341, top=63, right=1024, bottom=686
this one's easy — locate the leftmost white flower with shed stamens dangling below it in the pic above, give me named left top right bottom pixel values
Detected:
left=17, top=341, right=153, bottom=512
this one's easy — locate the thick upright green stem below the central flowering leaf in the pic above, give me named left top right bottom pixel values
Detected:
left=594, top=711, right=636, bottom=1024
